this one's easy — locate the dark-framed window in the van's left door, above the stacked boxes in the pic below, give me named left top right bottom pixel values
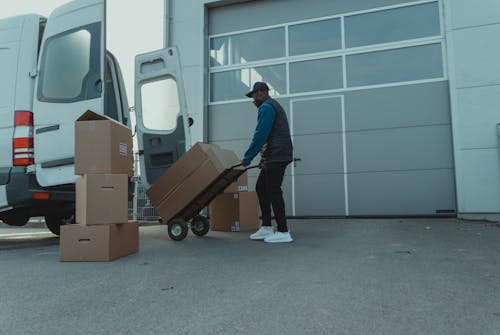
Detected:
left=37, top=23, right=102, bottom=103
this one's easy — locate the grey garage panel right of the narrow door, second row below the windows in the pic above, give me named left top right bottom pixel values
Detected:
left=347, top=126, right=453, bottom=172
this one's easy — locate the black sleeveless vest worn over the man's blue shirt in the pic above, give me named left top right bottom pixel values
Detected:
left=261, top=98, right=293, bottom=163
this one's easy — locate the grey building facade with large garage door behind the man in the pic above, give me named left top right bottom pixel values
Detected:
left=165, top=0, right=500, bottom=219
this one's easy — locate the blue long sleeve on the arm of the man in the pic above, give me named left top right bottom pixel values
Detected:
left=242, top=102, right=276, bottom=165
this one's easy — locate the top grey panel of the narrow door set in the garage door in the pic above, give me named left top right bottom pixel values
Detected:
left=293, top=97, right=342, bottom=135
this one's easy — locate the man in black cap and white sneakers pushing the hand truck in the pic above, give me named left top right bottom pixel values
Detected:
left=241, top=82, right=293, bottom=243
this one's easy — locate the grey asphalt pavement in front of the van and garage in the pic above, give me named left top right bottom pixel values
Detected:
left=0, top=219, right=500, bottom=335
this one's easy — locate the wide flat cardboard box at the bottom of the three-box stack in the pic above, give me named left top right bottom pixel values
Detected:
left=59, top=221, right=139, bottom=262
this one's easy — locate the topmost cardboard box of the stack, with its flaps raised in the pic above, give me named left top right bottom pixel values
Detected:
left=75, top=111, right=134, bottom=176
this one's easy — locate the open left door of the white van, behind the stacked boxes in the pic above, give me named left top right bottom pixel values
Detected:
left=33, top=0, right=106, bottom=186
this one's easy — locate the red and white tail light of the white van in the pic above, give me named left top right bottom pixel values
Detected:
left=12, top=111, right=35, bottom=166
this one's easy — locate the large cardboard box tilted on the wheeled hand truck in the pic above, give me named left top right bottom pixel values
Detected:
left=147, top=143, right=244, bottom=222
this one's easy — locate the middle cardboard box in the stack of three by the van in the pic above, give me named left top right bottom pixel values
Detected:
left=76, top=174, right=128, bottom=226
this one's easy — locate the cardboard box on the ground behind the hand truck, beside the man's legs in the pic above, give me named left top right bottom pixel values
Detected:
left=210, top=192, right=260, bottom=231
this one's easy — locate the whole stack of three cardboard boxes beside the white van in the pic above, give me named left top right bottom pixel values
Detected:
left=60, top=111, right=139, bottom=261
